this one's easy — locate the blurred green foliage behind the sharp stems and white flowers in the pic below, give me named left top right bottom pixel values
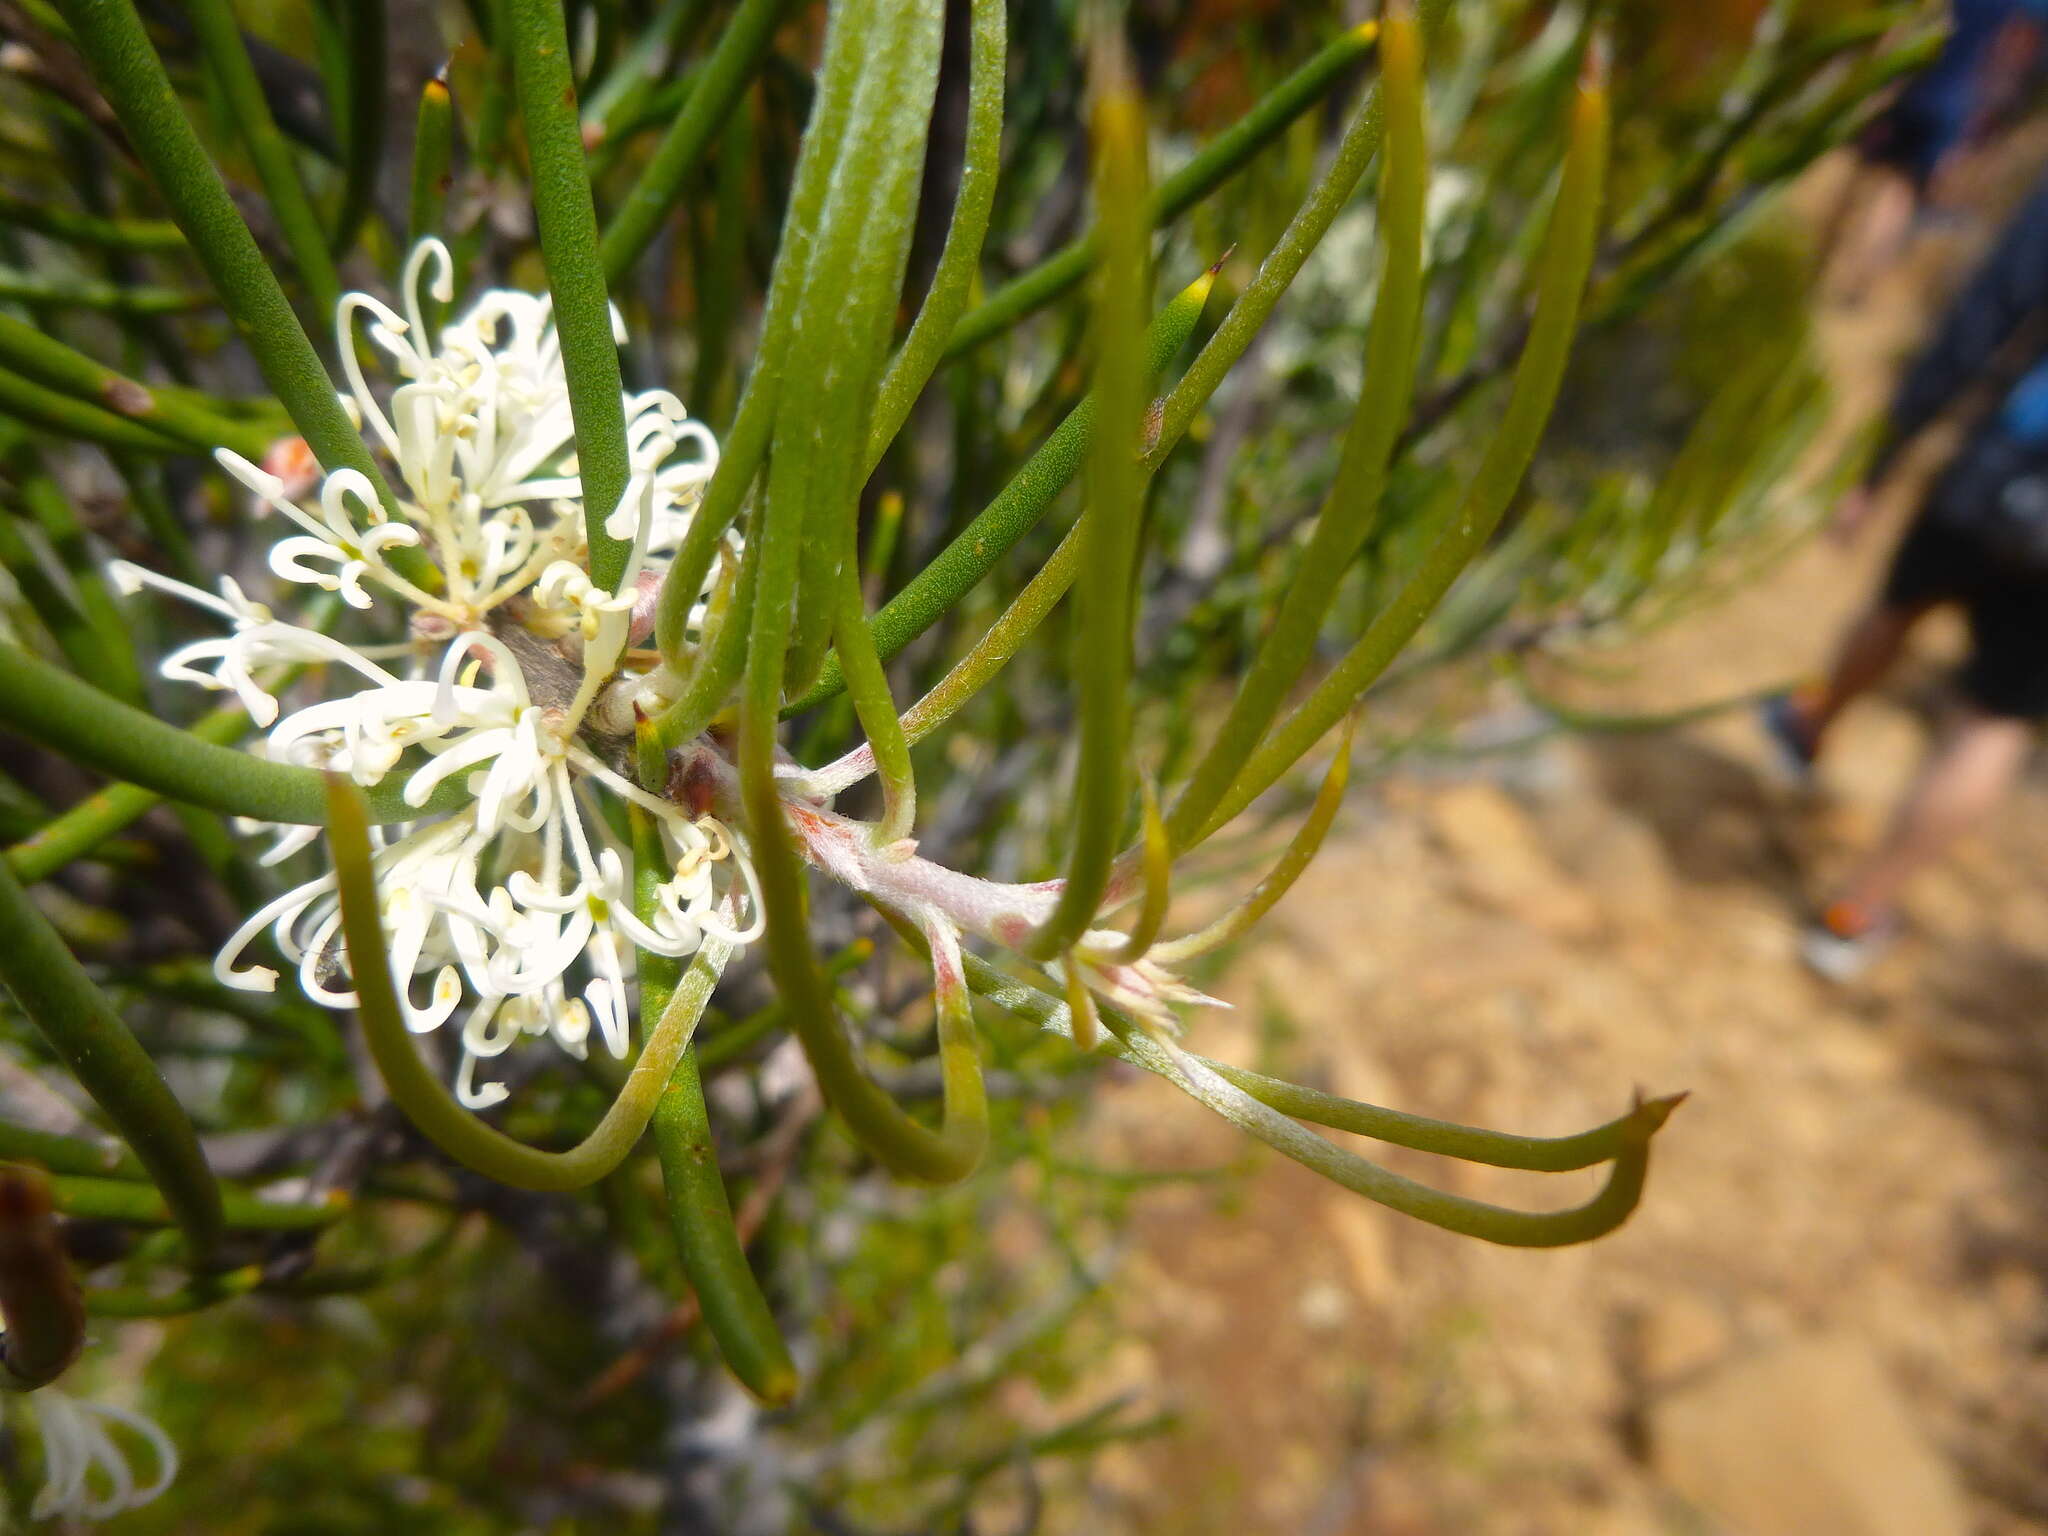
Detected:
left=0, top=0, right=1935, bottom=1532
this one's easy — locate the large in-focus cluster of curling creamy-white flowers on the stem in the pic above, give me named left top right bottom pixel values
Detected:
left=113, top=240, right=760, bottom=1108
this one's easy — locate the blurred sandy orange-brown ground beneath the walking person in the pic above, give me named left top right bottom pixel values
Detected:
left=1065, top=153, right=2048, bottom=1536
